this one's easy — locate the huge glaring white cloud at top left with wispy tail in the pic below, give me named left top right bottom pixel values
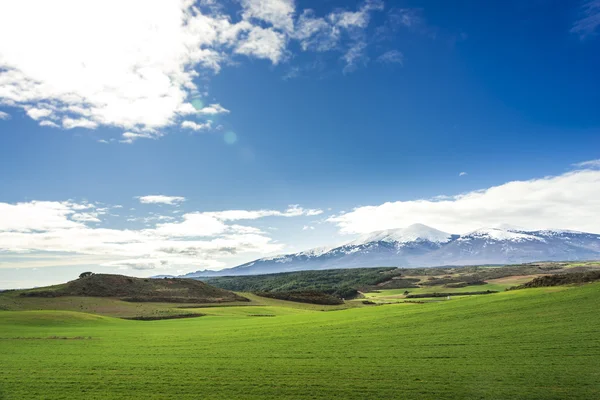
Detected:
left=0, top=0, right=392, bottom=138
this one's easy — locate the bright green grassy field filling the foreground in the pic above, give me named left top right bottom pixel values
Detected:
left=0, top=284, right=600, bottom=399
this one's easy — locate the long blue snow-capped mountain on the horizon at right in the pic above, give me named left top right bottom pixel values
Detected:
left=173, top=224, right=600, bottom=277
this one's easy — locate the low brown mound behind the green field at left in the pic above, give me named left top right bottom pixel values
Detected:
left=16, top=274, right=246, bottom=303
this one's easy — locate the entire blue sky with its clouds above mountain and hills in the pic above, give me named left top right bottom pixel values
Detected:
left=0, top=0, right=600, bottom=288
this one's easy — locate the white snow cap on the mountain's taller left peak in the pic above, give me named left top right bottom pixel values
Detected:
left=349, top=224, right=452, bottom=246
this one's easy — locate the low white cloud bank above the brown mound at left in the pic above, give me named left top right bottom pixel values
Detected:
left=0, top=201, right=315, bottom=270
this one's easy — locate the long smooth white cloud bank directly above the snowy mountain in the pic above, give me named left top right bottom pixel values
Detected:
left=328, top=170, right=600, bottom=233
